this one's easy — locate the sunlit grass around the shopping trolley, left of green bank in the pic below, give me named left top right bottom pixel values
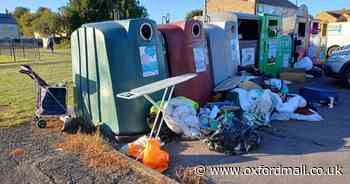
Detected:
left=0, top=62, right=73, bottom=127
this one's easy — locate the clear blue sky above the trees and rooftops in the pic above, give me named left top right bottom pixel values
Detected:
left=0, top=0, right=350, bottom=22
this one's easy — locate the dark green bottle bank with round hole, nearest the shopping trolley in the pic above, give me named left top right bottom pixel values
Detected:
left=71, top=19, right=168, bottom=136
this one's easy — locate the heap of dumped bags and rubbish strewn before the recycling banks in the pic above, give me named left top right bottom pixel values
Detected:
left=122, top=77, right=336, bottom=171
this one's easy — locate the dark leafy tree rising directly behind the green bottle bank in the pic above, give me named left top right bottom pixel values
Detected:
left=61, top=0, right=148, bottom=33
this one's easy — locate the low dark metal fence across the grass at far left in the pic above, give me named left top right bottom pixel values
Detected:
left=0, top=38, right=43, bottom=62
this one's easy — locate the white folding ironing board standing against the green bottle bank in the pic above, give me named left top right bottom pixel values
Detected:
left=117, top=73, right=197, bottom=138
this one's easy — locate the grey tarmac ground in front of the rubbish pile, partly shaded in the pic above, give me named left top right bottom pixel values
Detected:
left=169, top=80, right=350, bottom=184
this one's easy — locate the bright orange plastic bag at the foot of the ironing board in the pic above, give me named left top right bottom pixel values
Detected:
left=143, top=139, right=170, bottom=172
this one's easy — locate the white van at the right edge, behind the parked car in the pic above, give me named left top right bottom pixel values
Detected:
left=327, top=22, right=350, bottom=56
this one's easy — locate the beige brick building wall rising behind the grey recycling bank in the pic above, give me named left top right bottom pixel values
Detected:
left=208, top=0, right=255, bottom=14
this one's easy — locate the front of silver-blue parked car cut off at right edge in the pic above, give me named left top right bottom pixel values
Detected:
left=325, top=47, right=350, bottom=87
